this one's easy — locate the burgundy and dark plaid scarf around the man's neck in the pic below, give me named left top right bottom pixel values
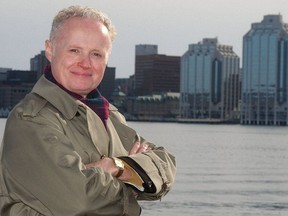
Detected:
left=44, top=66, right=109, bottom=127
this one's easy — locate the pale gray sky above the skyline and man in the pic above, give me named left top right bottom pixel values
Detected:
left=0, top=0, right=288, bottom=78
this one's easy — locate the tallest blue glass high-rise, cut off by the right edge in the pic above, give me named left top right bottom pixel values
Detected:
left=241, top=15, right=288, bottom=125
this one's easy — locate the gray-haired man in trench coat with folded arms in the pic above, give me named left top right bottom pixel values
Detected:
left=0, top=6, right=176, bottom=216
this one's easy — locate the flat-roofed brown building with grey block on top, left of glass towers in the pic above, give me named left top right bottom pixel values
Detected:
left=134, top=45, right=180, bottom=96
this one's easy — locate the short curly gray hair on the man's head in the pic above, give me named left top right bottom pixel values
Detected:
left=50, top=5, right=116, bottom=41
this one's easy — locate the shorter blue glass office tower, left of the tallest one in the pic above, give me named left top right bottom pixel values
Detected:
left=180, top=38, right=239, bottom=121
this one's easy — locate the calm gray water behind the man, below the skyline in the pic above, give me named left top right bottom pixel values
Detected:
left=0, top=119, right=288, bottom=216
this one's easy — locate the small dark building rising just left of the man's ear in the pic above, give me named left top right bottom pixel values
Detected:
left=30, top=50, right=49, bottom=79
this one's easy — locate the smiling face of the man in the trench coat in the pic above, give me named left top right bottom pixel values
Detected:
left=46, top=18, right=112, bottom=97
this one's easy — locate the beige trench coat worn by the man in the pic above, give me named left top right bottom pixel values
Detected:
left=0, top=77, right=176, bottom=216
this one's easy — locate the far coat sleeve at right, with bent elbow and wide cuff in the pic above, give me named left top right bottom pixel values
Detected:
left=110, top=108, right=176, bottom=200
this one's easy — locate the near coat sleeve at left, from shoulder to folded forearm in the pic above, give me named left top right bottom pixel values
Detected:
left=2, top=107, right=140, bottom=216
